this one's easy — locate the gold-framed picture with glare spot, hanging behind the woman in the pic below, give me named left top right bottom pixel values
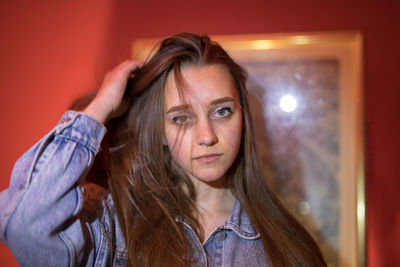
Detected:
left=132, top=32, right=366, bottom=267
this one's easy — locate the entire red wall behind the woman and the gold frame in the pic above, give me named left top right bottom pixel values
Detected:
left=0, top=0, right=400, bottom=267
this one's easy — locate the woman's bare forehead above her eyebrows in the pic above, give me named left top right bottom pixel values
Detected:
left=164, top=64, right=239, bottom=109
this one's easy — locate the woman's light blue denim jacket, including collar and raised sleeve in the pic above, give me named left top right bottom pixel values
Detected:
left=0, top=111, right=269, bottom=267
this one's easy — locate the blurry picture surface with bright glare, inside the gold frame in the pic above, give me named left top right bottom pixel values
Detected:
left=242, top=59, right=340, bottom=266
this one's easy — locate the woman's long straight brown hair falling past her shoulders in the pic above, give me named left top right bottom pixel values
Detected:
left=109, top=33, right=326, bottom=266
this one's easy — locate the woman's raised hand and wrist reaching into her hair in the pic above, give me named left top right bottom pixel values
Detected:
left=83, top=60, right=143, bottom=124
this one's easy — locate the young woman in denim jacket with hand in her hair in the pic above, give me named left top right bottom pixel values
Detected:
left=0, top=34, right=326, bottom=266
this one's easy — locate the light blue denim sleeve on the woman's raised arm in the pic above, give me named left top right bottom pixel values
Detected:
left=0, top=111, right=106, bottom=266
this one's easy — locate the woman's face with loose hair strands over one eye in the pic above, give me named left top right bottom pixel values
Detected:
left=164, top=65, right=242, bottom=186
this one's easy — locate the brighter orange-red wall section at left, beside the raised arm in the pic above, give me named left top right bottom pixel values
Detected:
left=0, top=1, right=114, bottom=267
